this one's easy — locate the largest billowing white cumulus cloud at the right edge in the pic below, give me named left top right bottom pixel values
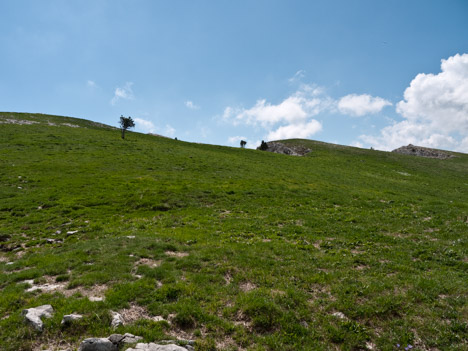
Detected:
left=359, top=54, right=468, bottom=152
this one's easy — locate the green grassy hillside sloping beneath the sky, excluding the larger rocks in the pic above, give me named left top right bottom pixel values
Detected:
left=0, top=113, right=468, bottom=350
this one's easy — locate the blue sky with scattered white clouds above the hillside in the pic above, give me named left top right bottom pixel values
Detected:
left=0, top=0, right=468, bottom=152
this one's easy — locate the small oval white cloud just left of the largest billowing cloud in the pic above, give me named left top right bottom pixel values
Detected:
left=338, top=94, right=392, bottom=116
